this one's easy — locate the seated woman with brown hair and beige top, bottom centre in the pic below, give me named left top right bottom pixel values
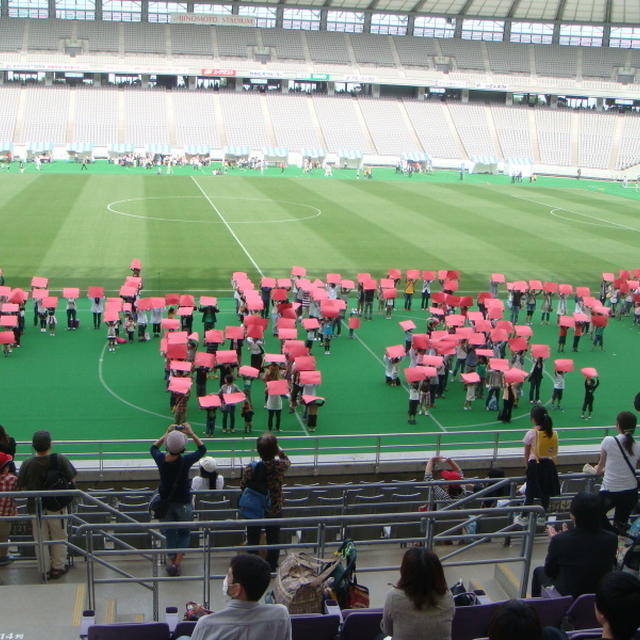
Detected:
left=380, top=547, right=455, bottom=640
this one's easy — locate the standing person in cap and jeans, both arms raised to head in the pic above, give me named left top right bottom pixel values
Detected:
left=150, top=422, right=207, bottom=576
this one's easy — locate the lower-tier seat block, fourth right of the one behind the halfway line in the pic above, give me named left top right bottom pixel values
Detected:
left=358, top=98, right=422, bottom=155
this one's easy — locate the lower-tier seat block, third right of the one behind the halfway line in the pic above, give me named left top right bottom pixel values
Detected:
left=313, top=96, right=374, bottom=153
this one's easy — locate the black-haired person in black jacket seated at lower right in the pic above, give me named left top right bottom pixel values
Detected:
left=531, top=492, right=618, bottom=598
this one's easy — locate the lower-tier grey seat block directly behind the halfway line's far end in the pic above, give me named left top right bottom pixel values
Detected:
left=171, top=91, right=223, bottom=147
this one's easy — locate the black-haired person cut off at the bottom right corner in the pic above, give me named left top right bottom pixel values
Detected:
left=595, top=571, right=640, bottom=640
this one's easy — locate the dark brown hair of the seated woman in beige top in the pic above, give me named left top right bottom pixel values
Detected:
left=396, top=547, right=447, bottom=609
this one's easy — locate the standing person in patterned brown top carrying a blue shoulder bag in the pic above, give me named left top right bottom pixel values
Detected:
left=240, top=432, right=291, bottom=571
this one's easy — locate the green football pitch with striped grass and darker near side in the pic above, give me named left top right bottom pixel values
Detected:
left=0, top=163, right=640, bottom=458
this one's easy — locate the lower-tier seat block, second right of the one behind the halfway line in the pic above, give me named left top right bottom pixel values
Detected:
left=267, top=95, right=324, bottom=149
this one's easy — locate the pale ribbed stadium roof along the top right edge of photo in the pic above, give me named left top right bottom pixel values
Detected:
left=243, top=0, right=640, bottom=24
